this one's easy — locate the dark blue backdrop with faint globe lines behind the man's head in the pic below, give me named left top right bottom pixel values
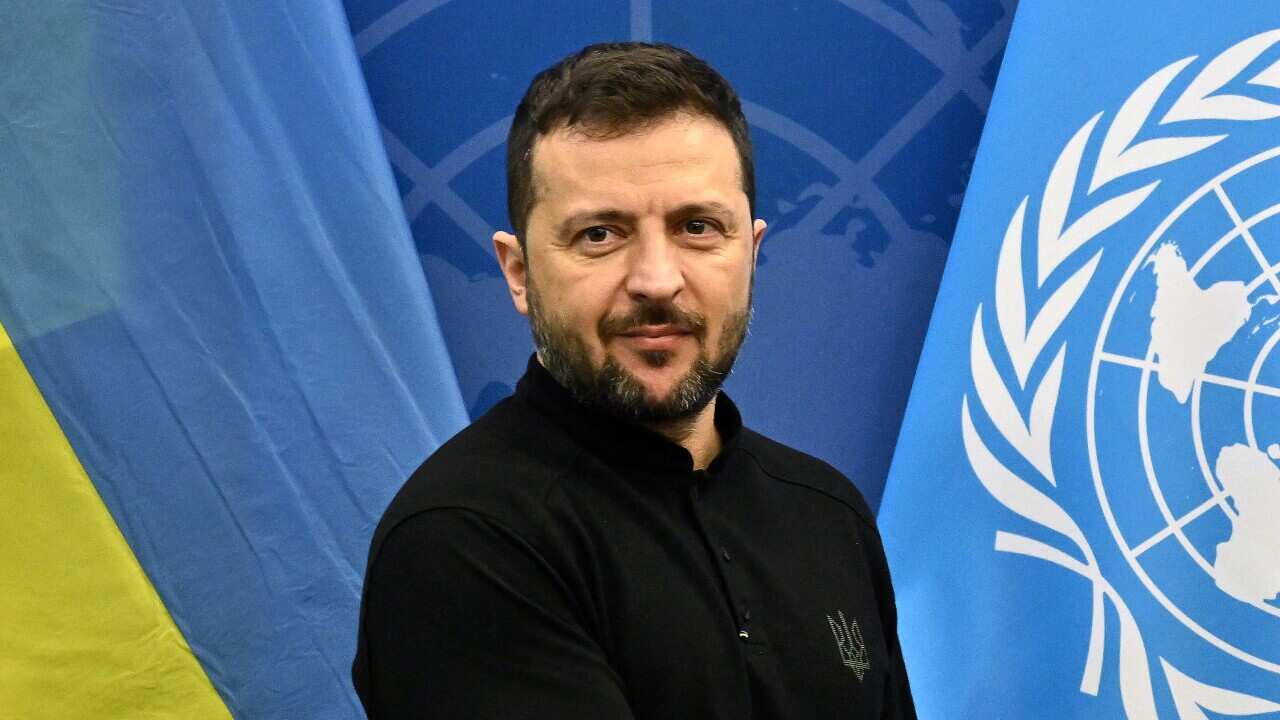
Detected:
left=347, top=0, right=1010, bottom=505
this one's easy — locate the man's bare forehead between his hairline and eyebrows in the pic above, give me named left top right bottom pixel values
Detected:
left=532, top=113, right=746, bottom=214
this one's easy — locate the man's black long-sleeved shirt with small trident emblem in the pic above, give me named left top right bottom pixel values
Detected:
left=353, top=360, right=915, bottom=720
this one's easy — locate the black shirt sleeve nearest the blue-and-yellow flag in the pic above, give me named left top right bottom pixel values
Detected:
left=356, top=509, right=632, bottom=720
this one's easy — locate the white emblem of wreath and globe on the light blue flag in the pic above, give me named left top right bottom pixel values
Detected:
left=961, top=31, right=1280, bottom=720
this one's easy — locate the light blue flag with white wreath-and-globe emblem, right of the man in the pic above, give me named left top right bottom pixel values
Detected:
left=881, top=1, right=1280, bottom=720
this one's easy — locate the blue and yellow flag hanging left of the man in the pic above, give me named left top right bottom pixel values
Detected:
left=0, top=0, right=466, bottom=719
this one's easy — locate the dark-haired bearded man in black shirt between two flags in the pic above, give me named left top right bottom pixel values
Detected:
left=355, top=44, right=915, bottom=720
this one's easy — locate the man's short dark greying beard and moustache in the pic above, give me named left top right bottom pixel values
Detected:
left=527, top=282, right=751, bottom=424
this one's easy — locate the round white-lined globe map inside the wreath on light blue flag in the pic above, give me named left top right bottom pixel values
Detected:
left=1088, top=149, right=1280, bottom=671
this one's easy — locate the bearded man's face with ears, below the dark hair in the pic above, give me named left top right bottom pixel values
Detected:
left=494, top=114, right=764, bottom=421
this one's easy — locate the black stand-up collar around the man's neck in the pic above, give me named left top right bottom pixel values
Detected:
left=516, top=354, right=742, bottom=483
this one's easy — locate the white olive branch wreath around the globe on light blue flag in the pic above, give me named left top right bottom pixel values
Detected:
left=960, top=29, right=1280, bottom=720
